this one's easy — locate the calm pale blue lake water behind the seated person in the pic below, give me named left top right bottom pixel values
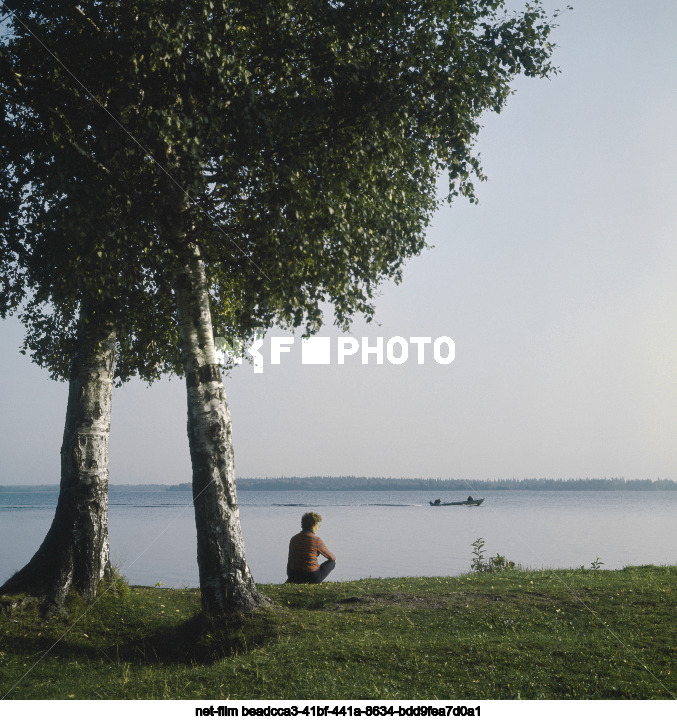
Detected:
left=0, top=487, right=677, bottom=587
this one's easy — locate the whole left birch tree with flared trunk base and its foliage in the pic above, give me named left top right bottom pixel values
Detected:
left=0, top=0, right=178, bottom=613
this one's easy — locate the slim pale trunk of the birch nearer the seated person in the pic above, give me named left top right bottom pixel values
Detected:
left=175, top=246, right=267, bottom=616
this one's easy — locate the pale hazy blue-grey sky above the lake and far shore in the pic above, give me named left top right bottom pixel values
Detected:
left=0, top=0, right=677, bottom=485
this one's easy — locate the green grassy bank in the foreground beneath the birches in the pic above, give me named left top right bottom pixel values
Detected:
left=0, top=566, right=677, bottom=700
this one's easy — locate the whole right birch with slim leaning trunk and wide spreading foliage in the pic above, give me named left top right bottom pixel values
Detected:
left=2, top=0, right=553, bottom=613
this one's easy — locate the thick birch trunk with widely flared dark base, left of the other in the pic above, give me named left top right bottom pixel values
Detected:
left=0, top=310, right=115, bottom=614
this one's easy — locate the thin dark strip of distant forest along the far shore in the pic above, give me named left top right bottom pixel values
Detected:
left=0, top=476, right=677, bottom=493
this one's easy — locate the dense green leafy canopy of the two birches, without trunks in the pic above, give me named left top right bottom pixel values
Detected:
left=0, top=0, right=553, bottom=381
